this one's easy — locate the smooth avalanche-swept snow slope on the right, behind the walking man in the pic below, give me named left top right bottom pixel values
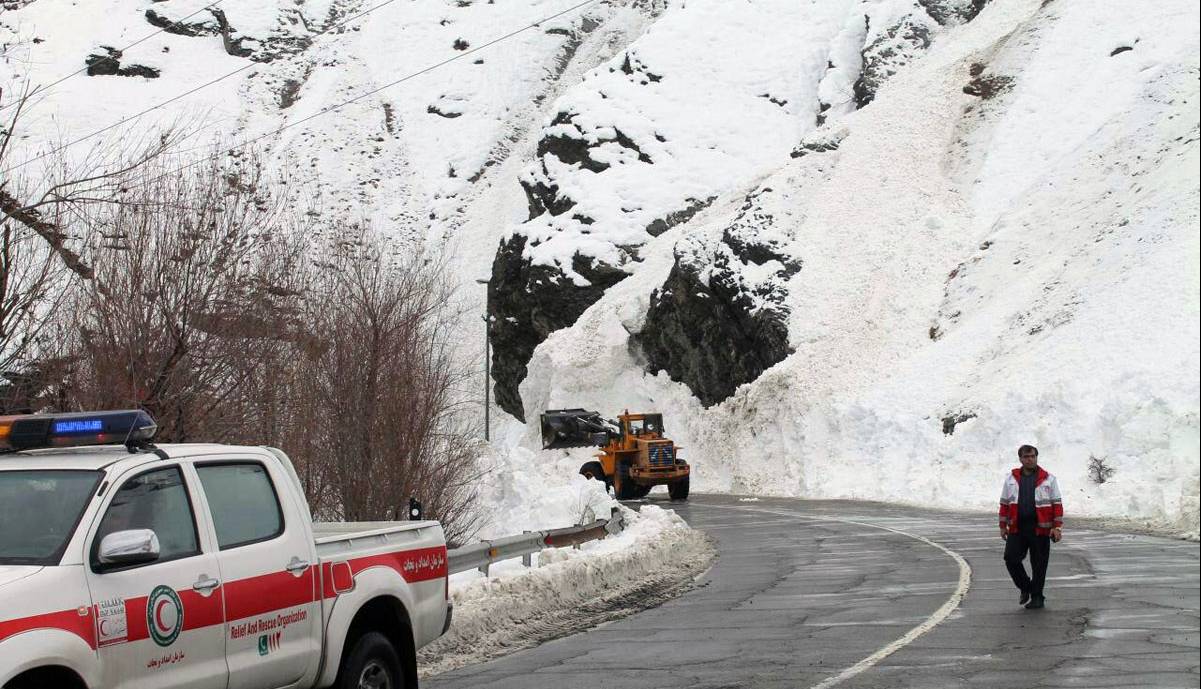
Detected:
left=521, top=0, right=1201, bottom=533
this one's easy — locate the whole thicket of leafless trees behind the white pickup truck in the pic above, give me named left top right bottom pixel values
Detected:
left=0, top=86, right=480, bottom=541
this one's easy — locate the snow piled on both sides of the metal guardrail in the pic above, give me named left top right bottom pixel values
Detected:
left=418, top=447, right=713, bottom=675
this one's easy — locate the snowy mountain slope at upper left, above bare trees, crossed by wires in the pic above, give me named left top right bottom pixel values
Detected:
left=0, top=0, right=656, bottom=246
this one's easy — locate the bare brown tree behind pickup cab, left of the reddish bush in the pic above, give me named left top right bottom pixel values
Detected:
left=62, top=151, right=305, bottom=442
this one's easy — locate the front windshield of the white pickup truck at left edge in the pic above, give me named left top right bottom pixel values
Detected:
left=0, top=471, right=101, bottom=565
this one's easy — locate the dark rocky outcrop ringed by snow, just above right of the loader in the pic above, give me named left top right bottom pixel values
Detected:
left=632, top=188, right=801, bottom=407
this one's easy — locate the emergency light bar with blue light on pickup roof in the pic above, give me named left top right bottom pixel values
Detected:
left=0, top=409, right=159, bottom=451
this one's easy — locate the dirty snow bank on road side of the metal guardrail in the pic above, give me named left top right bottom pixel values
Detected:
left=418, top=505, right=715, bottom=675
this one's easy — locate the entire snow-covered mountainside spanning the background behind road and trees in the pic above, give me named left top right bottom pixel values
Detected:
left=0, top=0, right=1201, bottom=532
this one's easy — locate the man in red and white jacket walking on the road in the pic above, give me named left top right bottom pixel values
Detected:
left=999, top=445, right=1063, bottom=610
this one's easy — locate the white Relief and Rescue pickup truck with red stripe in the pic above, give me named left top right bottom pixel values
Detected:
left=0, top=412, right=452, bottom=689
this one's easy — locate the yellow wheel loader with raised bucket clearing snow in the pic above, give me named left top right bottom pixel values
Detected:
left=542, top=409, right=689, bottom=501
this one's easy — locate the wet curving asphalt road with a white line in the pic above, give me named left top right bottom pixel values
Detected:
left=423, top=493, right=1201, bottom=689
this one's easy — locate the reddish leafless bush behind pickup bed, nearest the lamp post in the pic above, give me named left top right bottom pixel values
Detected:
left=281, top=227, right=479, bottom=540
